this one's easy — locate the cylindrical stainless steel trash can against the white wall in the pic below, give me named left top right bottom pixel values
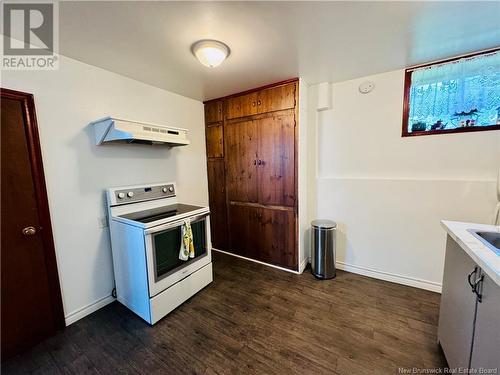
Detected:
left=311, top=220, right=337, bottom=279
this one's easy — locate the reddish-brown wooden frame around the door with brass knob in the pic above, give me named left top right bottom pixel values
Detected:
left=0, top=87, right=66, bottom=329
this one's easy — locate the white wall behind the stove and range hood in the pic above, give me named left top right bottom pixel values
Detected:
left=1, top=53, right=208, bottom=324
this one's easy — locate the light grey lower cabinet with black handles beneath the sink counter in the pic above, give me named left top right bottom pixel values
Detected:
left=438, top=236, right=500, bottom=373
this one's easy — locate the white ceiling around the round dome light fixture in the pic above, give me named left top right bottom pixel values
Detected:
left=59, top=1, right=500, bottom=100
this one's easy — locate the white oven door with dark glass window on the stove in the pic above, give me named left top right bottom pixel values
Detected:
left=144, top=213, right=212, bottom=297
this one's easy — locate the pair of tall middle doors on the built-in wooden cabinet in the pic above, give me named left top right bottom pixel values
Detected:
left=225, top=113, right=295, bottom=207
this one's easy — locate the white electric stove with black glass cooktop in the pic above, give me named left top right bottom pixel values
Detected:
left=107, top=183, right=213, bottom=324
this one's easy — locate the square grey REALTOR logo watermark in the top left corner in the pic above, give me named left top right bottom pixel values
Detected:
left=1, top=1, right=59, bottom=70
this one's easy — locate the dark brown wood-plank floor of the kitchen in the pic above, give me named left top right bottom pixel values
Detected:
left=2, top=253, right=446, bottom=375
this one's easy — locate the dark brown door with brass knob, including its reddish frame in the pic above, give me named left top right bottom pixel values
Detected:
left=1, top=89, right=64, bottom=360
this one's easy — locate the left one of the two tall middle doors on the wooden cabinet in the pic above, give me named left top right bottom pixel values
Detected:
left=224, top=121, right=258, bottom=202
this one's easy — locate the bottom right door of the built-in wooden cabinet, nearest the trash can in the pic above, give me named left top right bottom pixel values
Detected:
left=257, top=208, right=297, bottom=269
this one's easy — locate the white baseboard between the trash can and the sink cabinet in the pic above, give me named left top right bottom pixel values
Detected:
left=337, top=262, right=442, bottom=293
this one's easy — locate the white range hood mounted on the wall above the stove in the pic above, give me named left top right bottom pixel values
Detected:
left=91, top=117, right=189, bottom=147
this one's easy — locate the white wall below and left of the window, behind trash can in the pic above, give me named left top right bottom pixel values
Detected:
left=309, top=70, right=500, bottom=291
